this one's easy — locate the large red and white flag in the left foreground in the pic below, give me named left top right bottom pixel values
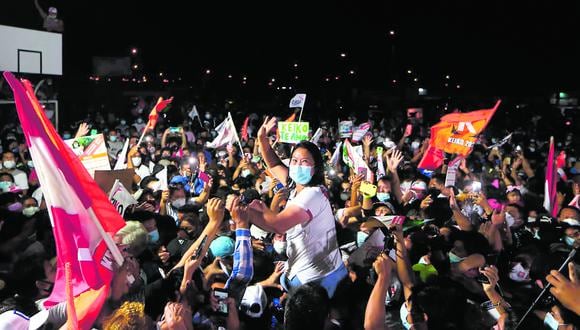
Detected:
left=4, top=72, right=125, bottom=329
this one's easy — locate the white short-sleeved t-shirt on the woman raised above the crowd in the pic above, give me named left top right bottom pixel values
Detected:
left=286, top=187, right=342, bottom=283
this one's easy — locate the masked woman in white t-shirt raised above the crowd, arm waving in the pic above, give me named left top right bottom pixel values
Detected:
left=248, top=118, right=347, bottom=297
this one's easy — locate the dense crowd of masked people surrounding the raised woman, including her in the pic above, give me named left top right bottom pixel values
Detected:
left=0, top=93, right=580, bottom=330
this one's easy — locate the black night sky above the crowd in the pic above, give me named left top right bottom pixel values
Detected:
left=0, top=0, right=580, bottom=95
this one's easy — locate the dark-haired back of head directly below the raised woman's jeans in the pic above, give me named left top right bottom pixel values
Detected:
left=284, top=283, right=330, bottom=330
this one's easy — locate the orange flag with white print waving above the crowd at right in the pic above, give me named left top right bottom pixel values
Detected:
left=429, top=101, right=501, bottom=157
